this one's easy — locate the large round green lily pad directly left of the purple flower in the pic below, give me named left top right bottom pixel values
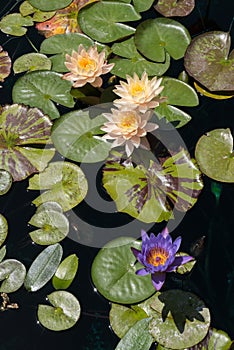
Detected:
left=91, top=237, right=155, bottom=304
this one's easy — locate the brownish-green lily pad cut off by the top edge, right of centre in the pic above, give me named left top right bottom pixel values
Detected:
left=154, top=0, right=195, bottom=17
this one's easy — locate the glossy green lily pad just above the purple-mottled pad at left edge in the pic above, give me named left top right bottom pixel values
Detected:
left=12, top=71, right=75, bottom=119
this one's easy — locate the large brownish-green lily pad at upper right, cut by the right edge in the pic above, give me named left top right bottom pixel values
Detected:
left=184, top=31, right=234, bottom=91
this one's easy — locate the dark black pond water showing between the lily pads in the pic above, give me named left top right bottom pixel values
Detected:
left=0, top=0, right=234, bottom=350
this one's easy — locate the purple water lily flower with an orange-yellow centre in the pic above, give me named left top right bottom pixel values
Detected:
left=131, top=228, right=193, bottom=290
